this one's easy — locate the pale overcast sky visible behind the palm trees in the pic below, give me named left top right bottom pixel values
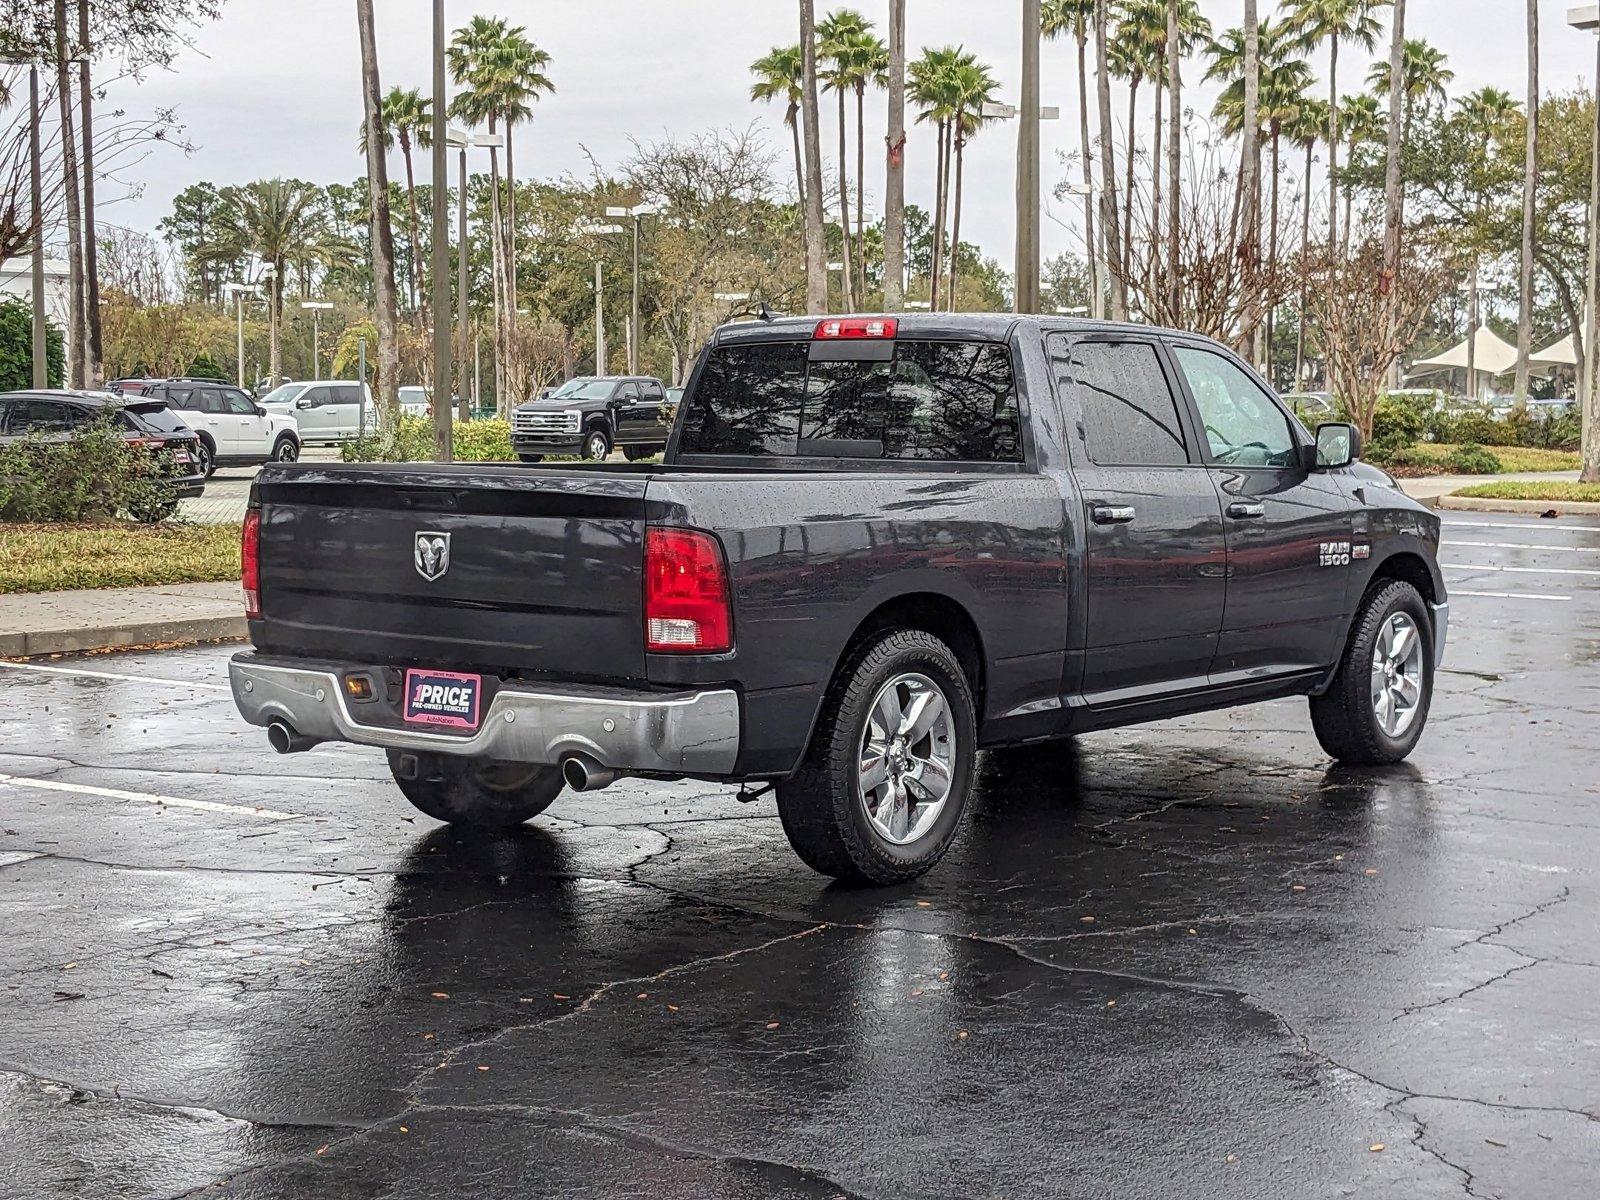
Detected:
left=101, top=0, right=1594, bottom=266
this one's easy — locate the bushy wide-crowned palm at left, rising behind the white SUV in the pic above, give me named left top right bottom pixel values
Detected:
left=203, top=179, right=347, bottom=381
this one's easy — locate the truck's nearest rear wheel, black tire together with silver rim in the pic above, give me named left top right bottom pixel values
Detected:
left=776, top=629, right=978, bottom=886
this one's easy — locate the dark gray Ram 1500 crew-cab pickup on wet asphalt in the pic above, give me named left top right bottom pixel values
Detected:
left=230, top=314, right=1448, bottom=883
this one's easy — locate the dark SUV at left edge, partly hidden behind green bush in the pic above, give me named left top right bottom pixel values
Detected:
left=0, top=389, right=205, bottom=504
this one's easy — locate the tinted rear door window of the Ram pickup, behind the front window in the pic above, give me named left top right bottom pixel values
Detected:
left=1051, top=341, right=1189, bottom=467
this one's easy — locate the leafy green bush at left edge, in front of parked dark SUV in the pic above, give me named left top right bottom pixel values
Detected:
left=0, top=421, right=176, bottom=522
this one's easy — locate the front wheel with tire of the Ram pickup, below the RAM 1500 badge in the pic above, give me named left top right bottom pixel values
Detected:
left=1310, top=579, right=1434, bottom=766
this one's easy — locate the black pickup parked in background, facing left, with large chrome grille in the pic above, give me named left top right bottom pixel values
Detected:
left=510, top=374, right=669, bottom=462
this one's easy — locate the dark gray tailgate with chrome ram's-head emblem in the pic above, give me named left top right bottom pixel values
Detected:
left=251, top=464, right=648, bottom=680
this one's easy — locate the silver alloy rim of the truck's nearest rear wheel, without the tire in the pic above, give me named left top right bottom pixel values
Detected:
left=856, top=672, right=955, bottom=846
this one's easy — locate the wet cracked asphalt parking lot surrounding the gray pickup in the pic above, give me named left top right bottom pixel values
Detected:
left=0, top=514, right=1600, bottom=1200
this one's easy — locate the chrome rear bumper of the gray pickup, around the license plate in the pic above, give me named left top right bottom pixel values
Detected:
left=227, top=651, right=739, bottom=776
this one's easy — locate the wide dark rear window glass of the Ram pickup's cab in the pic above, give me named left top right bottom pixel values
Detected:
left=680, top=339, right=1022, bottom=462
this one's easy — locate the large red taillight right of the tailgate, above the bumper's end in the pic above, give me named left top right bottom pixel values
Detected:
left=645, top=526, right=733, bottom=654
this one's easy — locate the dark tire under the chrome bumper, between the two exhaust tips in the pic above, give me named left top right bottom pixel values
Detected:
left=389, top=750, right=565, bottom=832
